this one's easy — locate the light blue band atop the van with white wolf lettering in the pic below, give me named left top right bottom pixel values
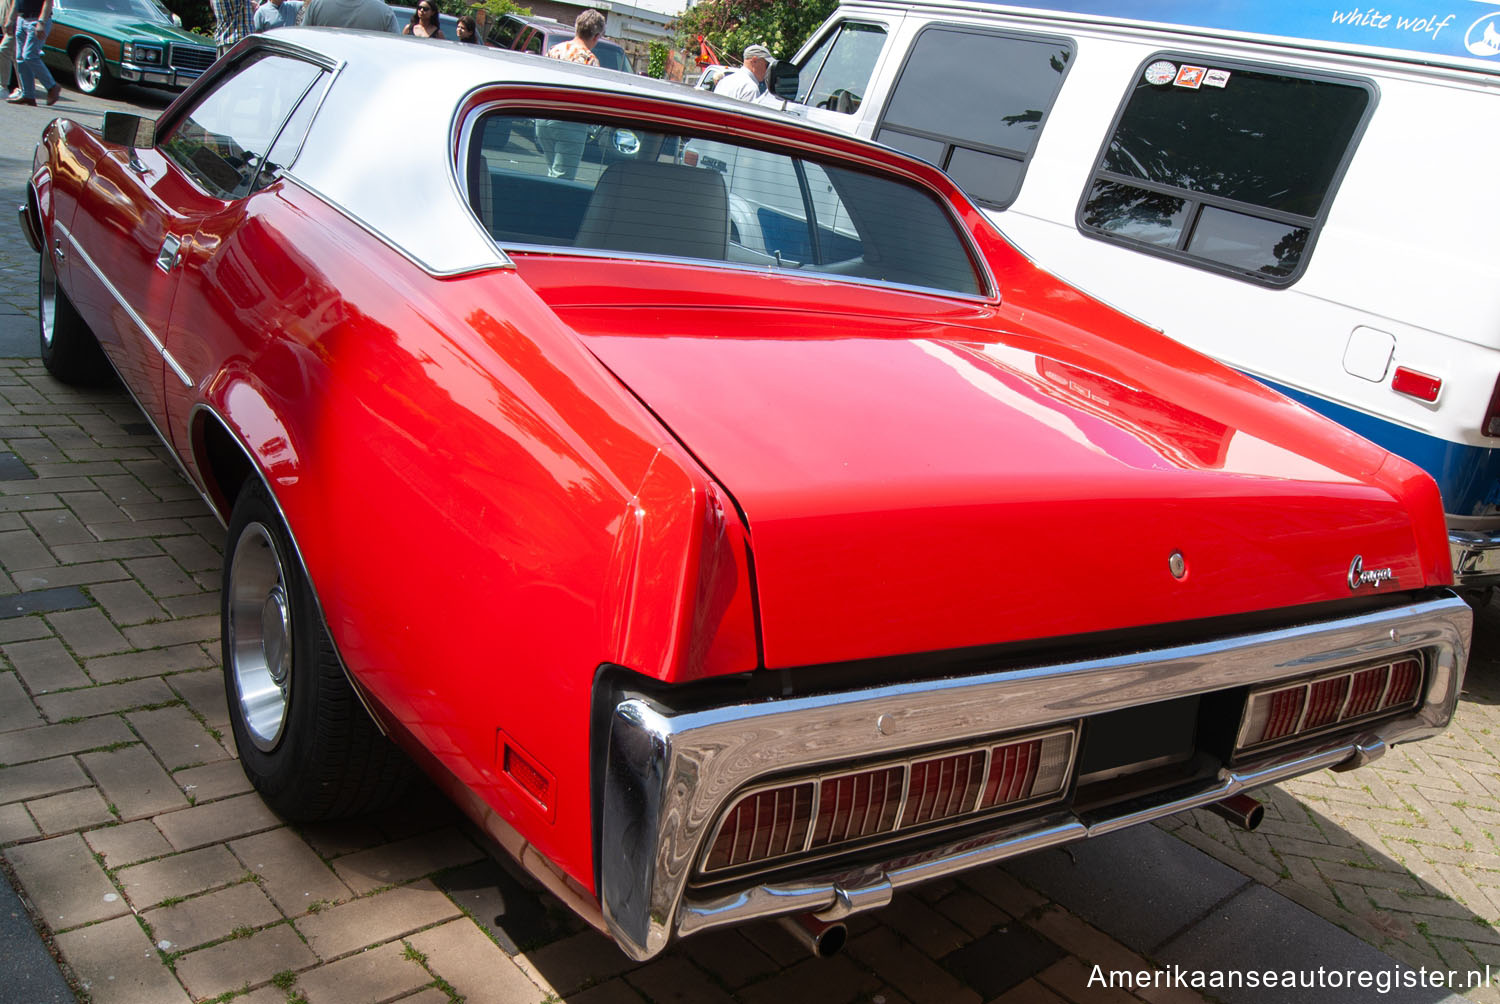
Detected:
left=972, top=0, right=1500, bottom=72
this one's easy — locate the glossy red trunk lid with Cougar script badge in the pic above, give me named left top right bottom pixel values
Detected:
left=522, top=256, right=1445, bottom=668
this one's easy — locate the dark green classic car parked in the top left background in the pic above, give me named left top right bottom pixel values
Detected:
left=42, top=0, right=218, bottom=95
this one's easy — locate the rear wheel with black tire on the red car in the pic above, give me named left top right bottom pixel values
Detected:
left=219, top=477, right=413, bottom=821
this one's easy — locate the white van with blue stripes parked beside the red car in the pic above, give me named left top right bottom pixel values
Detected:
left=794, top=0, right=1500, bottom=587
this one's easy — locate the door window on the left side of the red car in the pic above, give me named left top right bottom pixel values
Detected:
left=158, top=54, right=323, bottom=200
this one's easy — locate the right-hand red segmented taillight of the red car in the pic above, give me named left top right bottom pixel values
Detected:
left=1238, top=659, right=1422, bottom=749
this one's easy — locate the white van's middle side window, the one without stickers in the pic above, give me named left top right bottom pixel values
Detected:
left=875, top=26, right=1073, bottom=209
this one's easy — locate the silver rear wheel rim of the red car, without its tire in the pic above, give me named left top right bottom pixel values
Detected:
left=225, top=522, right=293, bottom=753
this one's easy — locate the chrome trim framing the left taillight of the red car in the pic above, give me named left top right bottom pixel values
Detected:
left=695, top=722, right=1079, bottom=881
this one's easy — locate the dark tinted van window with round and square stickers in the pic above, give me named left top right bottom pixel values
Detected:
left=1079, top=56, right=1373, bottom=285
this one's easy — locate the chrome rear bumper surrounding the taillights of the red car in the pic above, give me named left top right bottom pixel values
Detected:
left=599, top=596, right=1473, bottom=959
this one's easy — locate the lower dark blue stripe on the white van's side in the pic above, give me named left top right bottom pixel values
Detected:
left=1257, top=377, right=1500, bottom=516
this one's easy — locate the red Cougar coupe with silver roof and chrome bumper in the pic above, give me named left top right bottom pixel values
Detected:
left=21, top=30, right=1470, bottom=959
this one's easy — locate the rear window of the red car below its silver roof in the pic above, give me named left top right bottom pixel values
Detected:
left=468, top=113, right=984, bottom=296
